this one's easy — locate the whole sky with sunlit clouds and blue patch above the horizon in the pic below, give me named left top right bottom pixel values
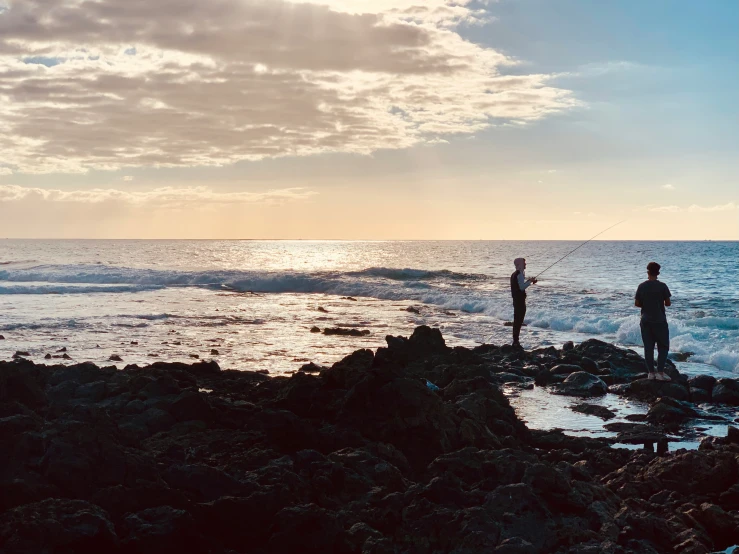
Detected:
left=0, top=0, right=739, bottom=240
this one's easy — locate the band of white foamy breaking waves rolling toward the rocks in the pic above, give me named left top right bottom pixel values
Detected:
left=0, top=264, right=739, bottom=371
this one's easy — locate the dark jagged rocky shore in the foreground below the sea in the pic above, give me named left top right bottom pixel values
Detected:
left=0, top=327, right=739, bottom=554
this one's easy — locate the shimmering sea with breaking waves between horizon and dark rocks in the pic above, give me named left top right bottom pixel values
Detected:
left=0, top=240, right=739, bottom=377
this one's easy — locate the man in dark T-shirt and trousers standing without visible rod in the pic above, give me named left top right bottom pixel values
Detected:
left=634, top=262, right=672, bottom=381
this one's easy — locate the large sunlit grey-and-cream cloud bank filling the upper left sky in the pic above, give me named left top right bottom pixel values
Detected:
left=0, top=0, right=579, bottom=173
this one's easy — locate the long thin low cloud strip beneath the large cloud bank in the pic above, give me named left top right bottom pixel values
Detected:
left=0, top=185, right=317, bottom=208
